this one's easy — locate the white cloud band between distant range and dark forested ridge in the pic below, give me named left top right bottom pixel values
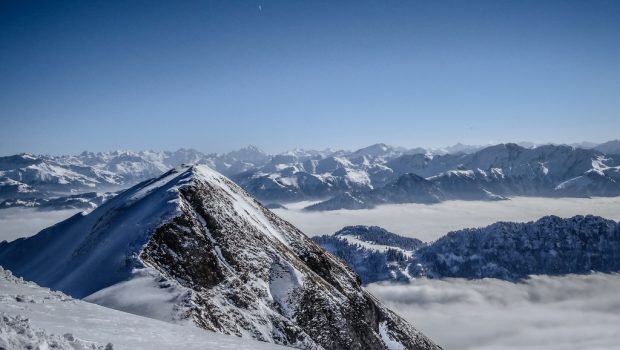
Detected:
left=274, top=197, right=620, bottom=241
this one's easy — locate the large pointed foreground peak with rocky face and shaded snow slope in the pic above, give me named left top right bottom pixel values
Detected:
left=0, top=165, right=439, bottom=349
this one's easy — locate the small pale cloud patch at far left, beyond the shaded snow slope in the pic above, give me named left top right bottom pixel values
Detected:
left=0, top=208, right=80, bottom=242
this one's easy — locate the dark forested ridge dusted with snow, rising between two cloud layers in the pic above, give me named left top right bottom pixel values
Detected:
left=313, top=216, right=620, bottom=283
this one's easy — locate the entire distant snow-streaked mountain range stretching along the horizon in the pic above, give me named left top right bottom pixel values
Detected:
left=0, top=141, right=620, bottom=210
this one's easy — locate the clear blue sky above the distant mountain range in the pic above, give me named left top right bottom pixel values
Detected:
left=0, top=0, right=620, bottom=154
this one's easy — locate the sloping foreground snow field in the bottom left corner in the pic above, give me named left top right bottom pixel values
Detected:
left=0, top=268, right=284, bottom=350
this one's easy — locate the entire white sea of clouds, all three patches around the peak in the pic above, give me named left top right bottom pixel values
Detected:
left=0, top=197, right=620, bottom=350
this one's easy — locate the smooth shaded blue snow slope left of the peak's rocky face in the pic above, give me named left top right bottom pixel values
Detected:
left=0, top=170, right=188, bottom=298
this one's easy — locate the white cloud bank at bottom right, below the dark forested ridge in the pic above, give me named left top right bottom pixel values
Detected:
left=368, top=273, right=620, bottom=350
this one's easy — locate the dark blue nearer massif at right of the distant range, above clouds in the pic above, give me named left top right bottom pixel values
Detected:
left=308, top=144, right=620, bottom=210
